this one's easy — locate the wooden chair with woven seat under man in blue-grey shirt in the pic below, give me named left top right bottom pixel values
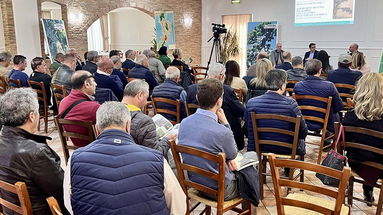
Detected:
left=170, top=141, right=253, bottom=215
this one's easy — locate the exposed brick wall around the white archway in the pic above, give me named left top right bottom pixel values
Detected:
left=1, top=0, right=202, bottom=64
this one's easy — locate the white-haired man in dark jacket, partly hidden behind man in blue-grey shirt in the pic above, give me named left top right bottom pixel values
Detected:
left=186, top=63, right=245, bottom=150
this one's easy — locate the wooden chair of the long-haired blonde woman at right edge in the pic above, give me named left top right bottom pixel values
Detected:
left=335, top=122, right=383, bottom=215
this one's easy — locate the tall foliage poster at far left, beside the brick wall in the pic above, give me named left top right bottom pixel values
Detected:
left=41, top=19, right=69, bottom=59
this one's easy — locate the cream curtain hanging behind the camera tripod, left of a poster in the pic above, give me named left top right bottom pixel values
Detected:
left=222, top=14, right=252, bottom=77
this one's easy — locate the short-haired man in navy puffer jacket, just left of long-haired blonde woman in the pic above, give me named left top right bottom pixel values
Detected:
left=294, top=59, right=343, bottom=136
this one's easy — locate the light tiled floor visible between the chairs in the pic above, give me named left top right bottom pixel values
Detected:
left=39, top=122, right=379, bottom=215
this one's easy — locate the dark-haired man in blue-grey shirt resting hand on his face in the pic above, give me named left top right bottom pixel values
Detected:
left=178, top=78, right=239, bottom=200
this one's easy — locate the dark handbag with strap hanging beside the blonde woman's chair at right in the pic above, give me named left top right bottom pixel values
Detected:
left=315, top=125, right=347, bottom=187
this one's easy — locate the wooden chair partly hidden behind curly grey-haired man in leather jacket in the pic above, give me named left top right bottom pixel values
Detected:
left=28, top=80, right=52, bottom=133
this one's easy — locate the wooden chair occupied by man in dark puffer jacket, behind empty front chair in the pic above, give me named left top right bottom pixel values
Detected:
left=250, top=112, right=304, bottom=199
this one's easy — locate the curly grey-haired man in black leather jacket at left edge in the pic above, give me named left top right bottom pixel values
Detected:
left=0, top=88, right=68, bottom=215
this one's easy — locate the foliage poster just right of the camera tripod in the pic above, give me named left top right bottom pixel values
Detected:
left=247, top=21, right=278, bottom=68
